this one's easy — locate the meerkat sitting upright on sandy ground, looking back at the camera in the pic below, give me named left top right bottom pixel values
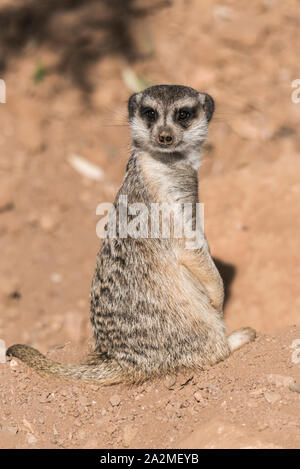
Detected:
left=7, top=85, right=256, bottom=385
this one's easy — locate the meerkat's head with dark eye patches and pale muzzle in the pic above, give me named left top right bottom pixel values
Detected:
left=128, top=85, right=214, bottom=164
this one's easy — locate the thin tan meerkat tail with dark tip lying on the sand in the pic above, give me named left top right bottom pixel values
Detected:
left=6, top=344, right=125, bottom=386
